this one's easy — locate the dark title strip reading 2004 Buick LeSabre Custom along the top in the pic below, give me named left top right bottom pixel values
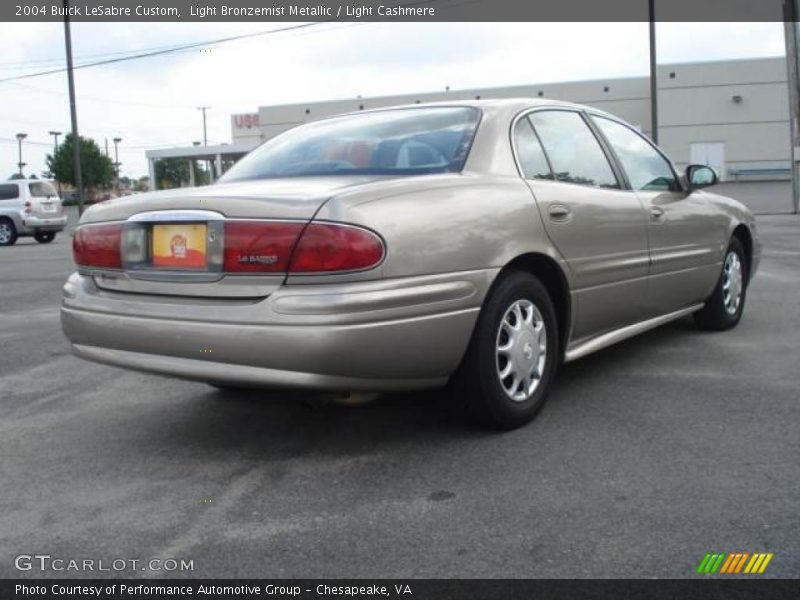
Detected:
left=0, top=0, right=797, bottom=23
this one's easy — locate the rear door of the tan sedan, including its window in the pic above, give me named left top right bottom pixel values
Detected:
left=514, top=109, right=649, bottom=341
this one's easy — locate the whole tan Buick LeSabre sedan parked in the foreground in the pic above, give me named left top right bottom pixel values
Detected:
left=61, top=99, right=760, bottom=428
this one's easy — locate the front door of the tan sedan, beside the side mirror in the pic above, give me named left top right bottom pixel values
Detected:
left=591, top=115, right=727, bottom=316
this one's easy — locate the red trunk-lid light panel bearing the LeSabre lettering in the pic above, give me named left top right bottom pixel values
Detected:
left=222, top=221, right=303, bottom=273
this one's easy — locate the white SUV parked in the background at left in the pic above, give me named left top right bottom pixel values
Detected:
left=0, top=179, right=67, bottom=246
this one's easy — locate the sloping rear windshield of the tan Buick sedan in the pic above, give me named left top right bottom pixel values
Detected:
left=222, top=107, right=480, bottom=181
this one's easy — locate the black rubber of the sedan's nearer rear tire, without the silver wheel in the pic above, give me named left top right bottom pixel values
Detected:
left=450, top=271, right=560, bottom=429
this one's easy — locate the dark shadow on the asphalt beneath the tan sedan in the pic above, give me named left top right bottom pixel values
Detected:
left=133, top=319, right=708, bottom=459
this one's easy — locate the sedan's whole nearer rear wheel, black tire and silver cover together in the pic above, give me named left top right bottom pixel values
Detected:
left=451, top=271, right=560, bottom=430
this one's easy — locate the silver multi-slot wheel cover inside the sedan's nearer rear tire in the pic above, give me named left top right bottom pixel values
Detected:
left=495, top=300, right=547, bottom=402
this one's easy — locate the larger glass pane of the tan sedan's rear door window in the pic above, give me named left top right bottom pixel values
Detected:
left=530, top=110, right=619, bottom=189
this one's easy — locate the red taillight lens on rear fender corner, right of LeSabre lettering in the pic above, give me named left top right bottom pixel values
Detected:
left=289, top=223, right=384, bottom=273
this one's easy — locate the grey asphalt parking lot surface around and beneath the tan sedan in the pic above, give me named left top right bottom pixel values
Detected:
left=0, top=209, right=800, bottom=578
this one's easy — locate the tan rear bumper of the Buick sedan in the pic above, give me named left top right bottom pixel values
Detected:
left=61, top=271, right=493, bottom=391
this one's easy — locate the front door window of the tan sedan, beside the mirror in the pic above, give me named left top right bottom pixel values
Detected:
left=592, top=117, right=680, bottom=192
